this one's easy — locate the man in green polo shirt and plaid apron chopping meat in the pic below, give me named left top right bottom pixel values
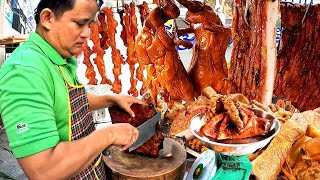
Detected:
left=0, top=0, right=142, bottom=179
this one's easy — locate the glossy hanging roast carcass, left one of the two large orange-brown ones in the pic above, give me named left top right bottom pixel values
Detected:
left=136, top=7, right=194, bottom=107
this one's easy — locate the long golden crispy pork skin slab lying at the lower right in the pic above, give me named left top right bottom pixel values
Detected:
left=252, top=111, right=320, bottom=180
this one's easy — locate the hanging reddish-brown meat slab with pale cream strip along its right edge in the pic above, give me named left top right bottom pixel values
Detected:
left=227, top=0, right=279, bottom=104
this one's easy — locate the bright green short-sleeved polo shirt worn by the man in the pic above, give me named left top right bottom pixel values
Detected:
left=0, top=33, right=77, bottom=158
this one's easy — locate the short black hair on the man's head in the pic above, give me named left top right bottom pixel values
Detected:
left=34, top=0, right=103, bottom=24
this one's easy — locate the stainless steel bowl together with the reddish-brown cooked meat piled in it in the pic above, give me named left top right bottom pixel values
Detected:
left=189, top=107, right=280, bottom=156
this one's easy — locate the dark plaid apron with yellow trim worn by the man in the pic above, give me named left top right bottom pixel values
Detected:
left=58, top=66, right=106, bottom=180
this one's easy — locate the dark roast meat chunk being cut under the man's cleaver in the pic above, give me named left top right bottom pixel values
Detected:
left=109, top=104, right=164, bottom=157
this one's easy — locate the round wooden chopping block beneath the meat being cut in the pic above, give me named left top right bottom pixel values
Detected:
left=103, top=139, right=187, bottom=180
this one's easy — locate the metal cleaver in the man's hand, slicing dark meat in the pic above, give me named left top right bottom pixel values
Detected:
left=102, top=112, right=161, bottom=156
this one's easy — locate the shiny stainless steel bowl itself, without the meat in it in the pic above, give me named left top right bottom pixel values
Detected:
left=189, top=109, right=280, bottom=156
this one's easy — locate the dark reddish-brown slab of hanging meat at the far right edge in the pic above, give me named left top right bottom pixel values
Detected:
left=274, top=3, right=320, bottom=111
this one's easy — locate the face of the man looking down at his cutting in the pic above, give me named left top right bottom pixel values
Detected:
left=49, top=0, right=97, bottom=58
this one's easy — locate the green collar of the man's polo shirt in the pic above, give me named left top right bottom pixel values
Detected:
left=29, top=32, right=76, bottom=66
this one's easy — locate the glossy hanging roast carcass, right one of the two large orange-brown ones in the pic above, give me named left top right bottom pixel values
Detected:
left=178, top=0, right=231, bottom=96
